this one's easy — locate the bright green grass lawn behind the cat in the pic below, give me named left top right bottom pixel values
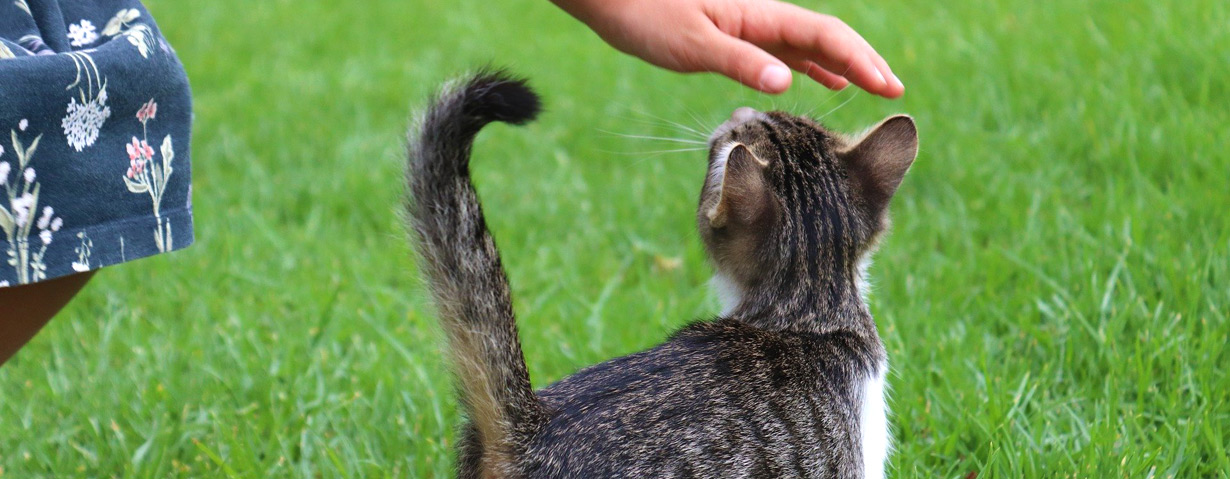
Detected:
left=0, top=0, right=1230, bottom=478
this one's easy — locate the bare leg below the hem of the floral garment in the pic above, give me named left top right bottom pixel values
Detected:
left=0, top=271, right=93, bottom=366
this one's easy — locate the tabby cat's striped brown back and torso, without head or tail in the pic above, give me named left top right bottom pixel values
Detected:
left=523, top=320, right=882, bottom=478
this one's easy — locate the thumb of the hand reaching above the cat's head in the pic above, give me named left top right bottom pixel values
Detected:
left=700, top=31, right=791, bottom=94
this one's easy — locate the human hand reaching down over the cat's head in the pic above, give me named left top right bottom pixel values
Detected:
left=552, top=0, right=905, bottom=99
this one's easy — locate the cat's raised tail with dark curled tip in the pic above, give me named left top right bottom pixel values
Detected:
left=406, top=71, right=545, bottom=477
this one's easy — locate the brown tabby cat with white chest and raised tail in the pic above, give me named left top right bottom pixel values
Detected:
left=406, top=70, right=918, bottom=479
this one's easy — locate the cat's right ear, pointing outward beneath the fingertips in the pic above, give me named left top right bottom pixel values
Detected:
left=838, top=115, right=919, bottom=213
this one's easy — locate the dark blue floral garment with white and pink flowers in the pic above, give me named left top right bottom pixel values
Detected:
left=0, top=0, right=193, bottom=287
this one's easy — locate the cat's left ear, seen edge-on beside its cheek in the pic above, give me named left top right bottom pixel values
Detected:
left=706, top=144, right=775, bottom=229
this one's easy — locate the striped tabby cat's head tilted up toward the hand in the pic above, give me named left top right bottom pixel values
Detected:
left=697, top=108, right=918, bottom=294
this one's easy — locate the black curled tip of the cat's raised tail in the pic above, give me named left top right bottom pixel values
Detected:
left=465, top=70, right=542, bottom=124
